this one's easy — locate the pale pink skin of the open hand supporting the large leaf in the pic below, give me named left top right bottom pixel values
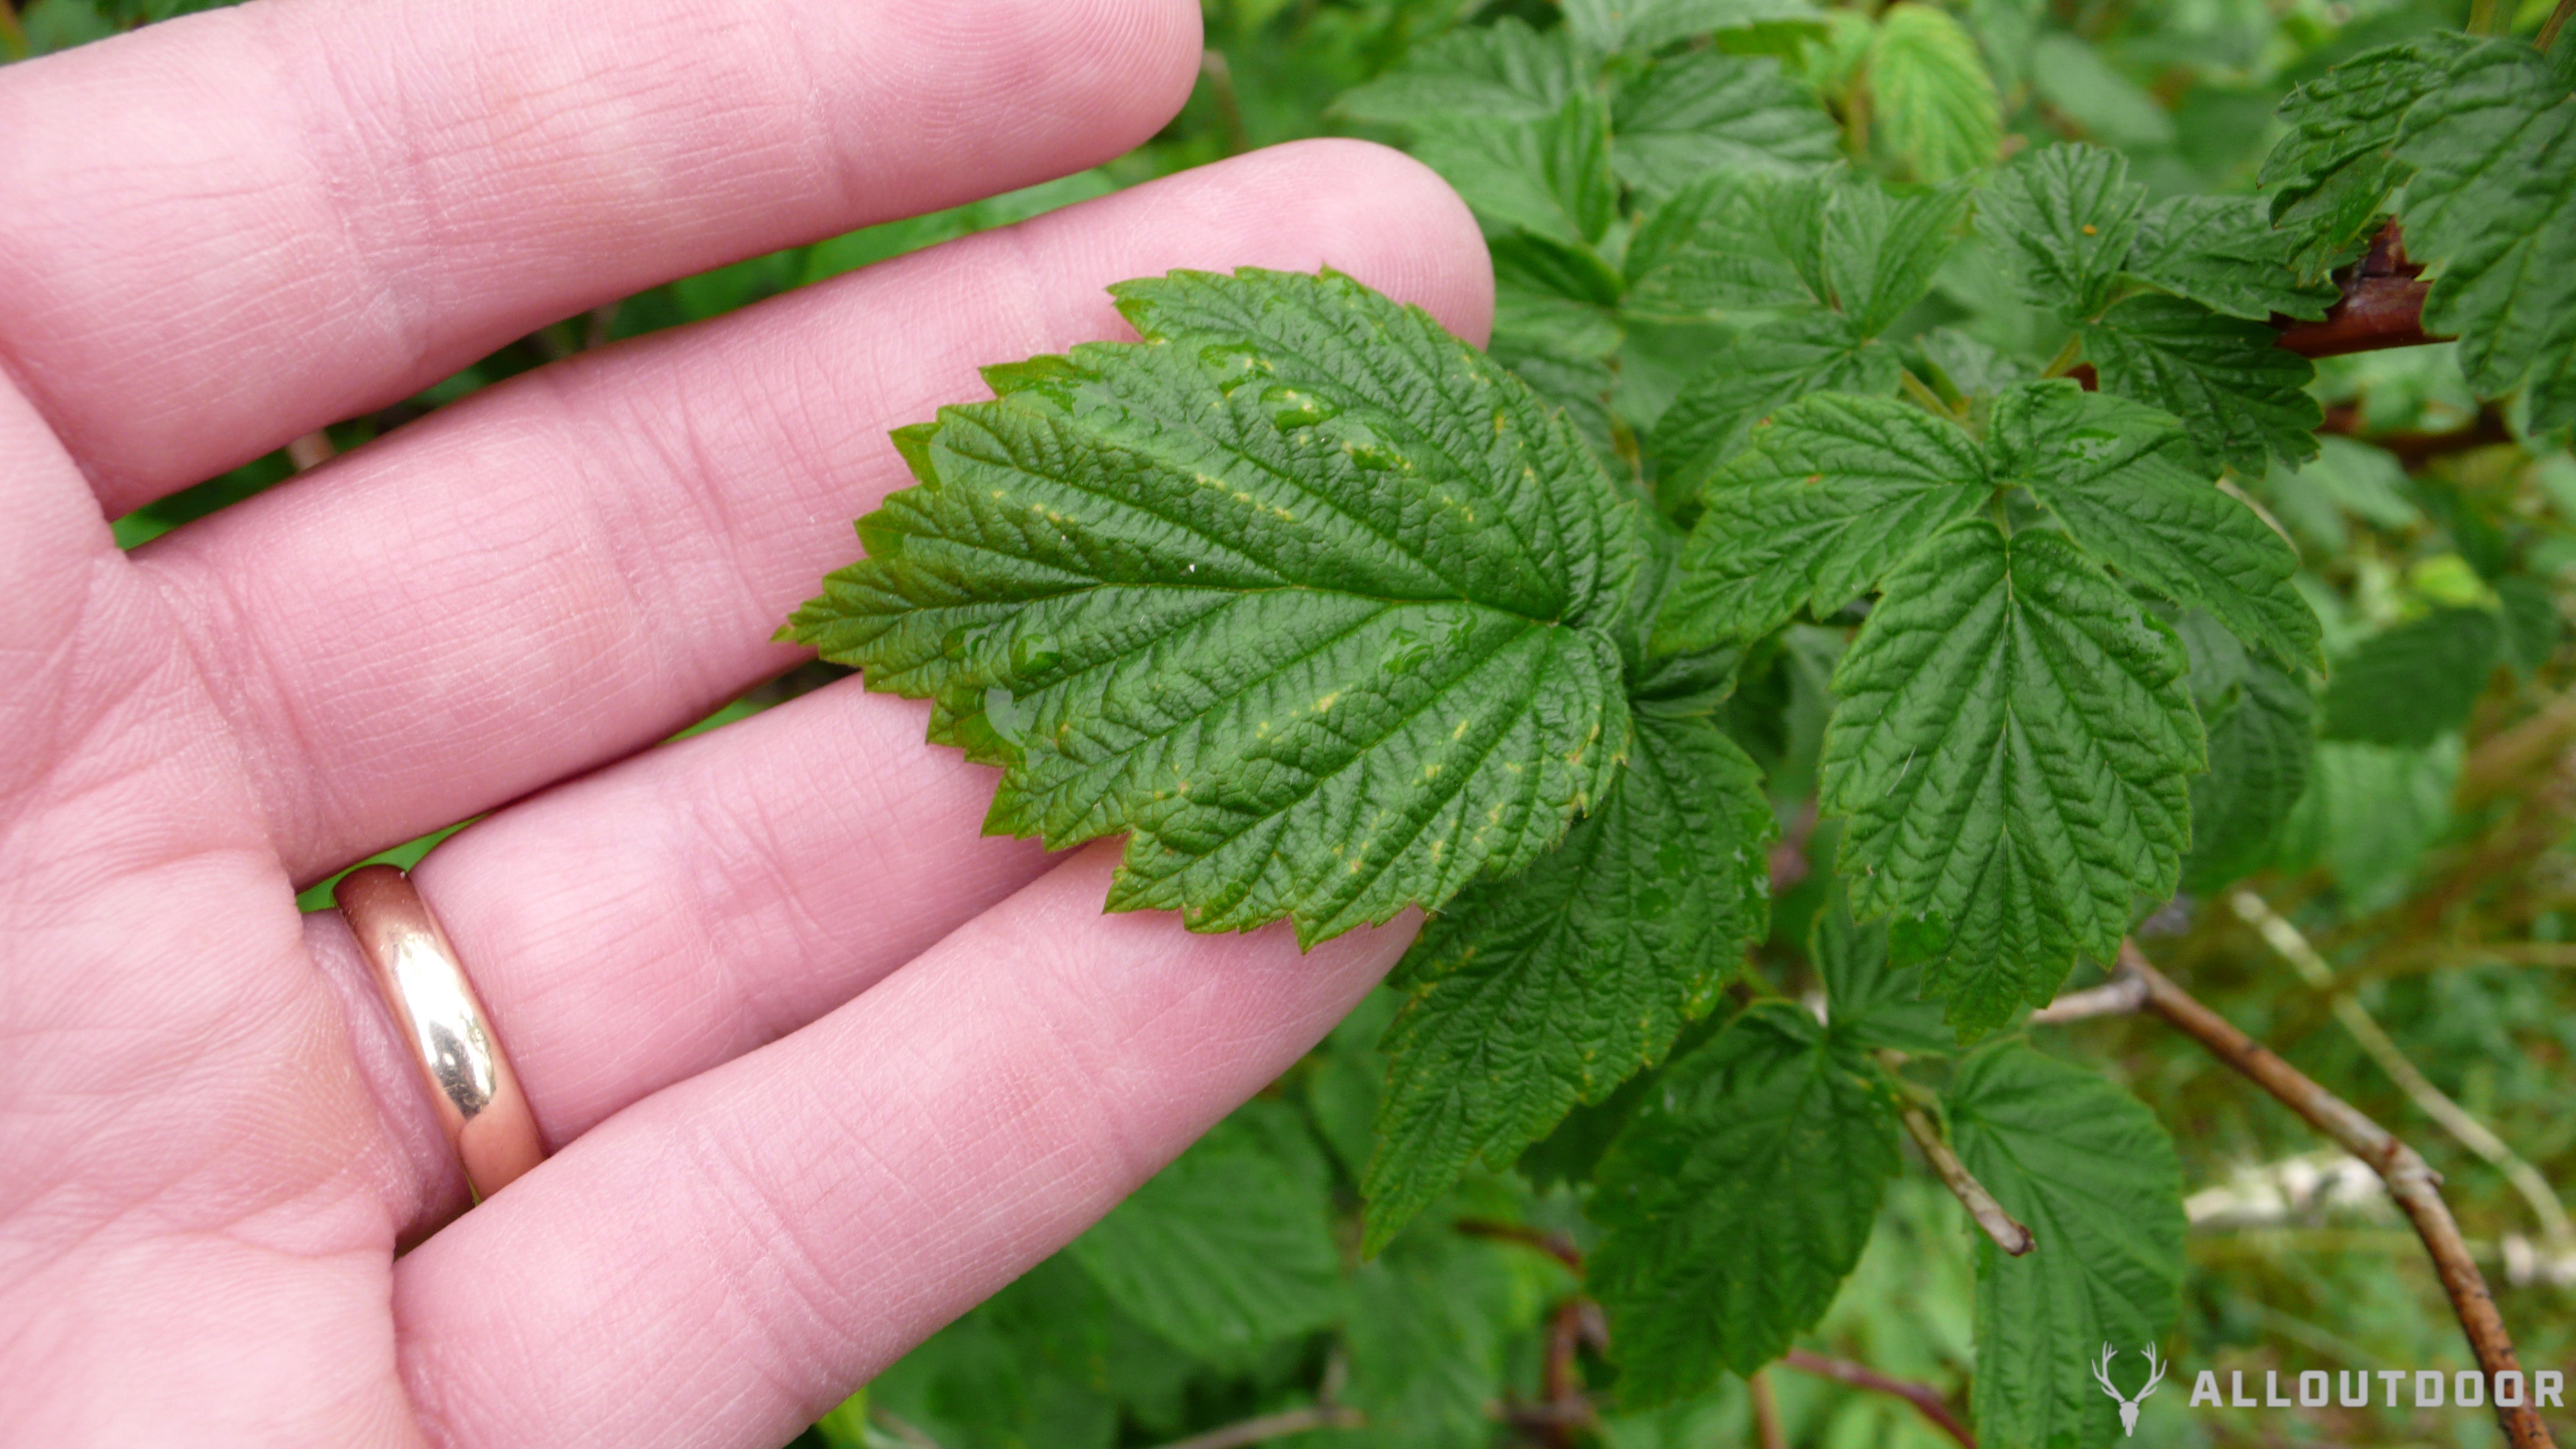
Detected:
left=0, top=0, right=1492, bottom=1449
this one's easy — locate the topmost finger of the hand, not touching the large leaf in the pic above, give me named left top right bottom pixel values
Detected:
left=0, top=0, right=1198, bottom=513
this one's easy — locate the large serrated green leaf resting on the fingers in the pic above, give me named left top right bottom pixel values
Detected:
left=789, top=271, right=1638, bottom=943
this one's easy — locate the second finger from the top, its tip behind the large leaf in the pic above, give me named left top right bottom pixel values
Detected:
left=139, top=142, right=1492, bottom=882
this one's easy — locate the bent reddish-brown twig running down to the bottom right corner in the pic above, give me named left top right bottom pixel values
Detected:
left=2120, top=941, right=2555, bottom=1449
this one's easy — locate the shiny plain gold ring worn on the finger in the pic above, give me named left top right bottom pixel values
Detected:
left=330, top=867, right=546, bottom=1201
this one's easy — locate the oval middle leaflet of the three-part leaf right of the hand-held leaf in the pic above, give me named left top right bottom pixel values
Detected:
left=1821, top=518, right=2205, bottom=1034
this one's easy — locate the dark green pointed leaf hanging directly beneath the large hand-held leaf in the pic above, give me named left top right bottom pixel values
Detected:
left=1362, top=706, right=1775, bottom=1253
